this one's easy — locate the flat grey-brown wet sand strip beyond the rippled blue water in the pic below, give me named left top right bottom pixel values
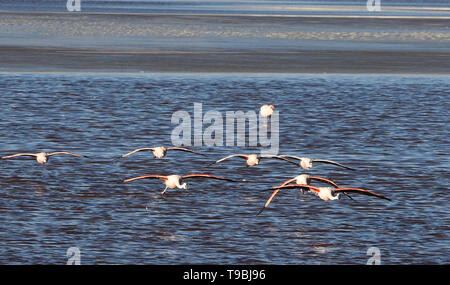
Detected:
left=0, top=12, right=450, bottom=74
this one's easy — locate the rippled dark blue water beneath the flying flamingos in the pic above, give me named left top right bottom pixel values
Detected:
left=0, top=73, right=450, bottom=264
